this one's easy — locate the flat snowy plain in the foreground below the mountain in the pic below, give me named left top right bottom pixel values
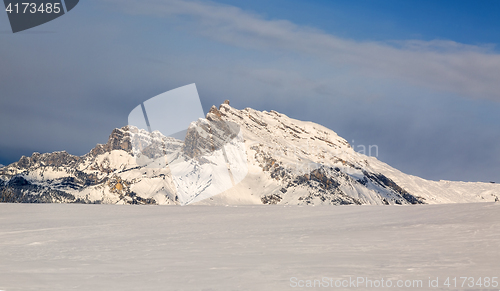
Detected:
left=0, top=203, right=500, bottom=291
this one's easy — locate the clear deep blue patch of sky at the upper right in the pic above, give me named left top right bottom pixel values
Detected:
left=219, top=0, right=500, bottom=44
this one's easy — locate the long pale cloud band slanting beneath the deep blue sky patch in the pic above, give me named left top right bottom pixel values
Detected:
left=109, top=0, right=500, bottom=101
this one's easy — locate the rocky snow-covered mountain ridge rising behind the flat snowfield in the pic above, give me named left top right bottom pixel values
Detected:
left=0, top=102, right=500, bottom=205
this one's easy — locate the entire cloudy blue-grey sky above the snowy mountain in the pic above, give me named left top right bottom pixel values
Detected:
left=0, top=0, right=500, bottom=181
